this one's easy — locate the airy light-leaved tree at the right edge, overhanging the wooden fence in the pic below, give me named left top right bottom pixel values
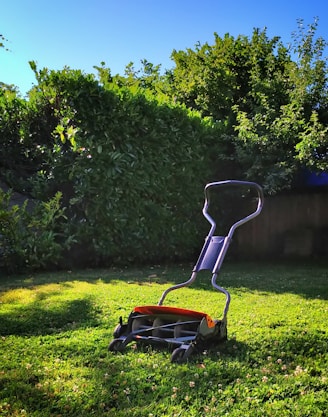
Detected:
left=235, top=21, right=328, bottom=188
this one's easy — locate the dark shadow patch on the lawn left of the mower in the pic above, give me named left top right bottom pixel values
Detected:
left=0, top=299, right=97, bottom=336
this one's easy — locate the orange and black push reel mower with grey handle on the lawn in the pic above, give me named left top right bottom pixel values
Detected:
left=108, top=180, right=263, bottom=363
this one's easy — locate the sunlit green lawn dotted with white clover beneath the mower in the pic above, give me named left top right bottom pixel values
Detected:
left=0, top=262, right=328, bottom=417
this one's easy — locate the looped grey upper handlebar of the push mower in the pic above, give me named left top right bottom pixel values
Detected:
left=203, top=180, right=264, bottom=238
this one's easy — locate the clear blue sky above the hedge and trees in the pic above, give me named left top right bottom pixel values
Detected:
left=0, top=0, right=328, bottom=95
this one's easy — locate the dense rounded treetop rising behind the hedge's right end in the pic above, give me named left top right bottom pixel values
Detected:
left=170, top=29, right=289, bottom=127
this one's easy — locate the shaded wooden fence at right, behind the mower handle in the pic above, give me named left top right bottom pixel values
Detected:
left=236, top=192, right=328, bottom=258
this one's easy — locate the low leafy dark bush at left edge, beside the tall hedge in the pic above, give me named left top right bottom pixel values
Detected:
left=0, top=190, right=73, bottom=272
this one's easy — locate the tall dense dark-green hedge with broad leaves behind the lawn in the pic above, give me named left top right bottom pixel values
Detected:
left=0, top=69, right=228, bottom=266
